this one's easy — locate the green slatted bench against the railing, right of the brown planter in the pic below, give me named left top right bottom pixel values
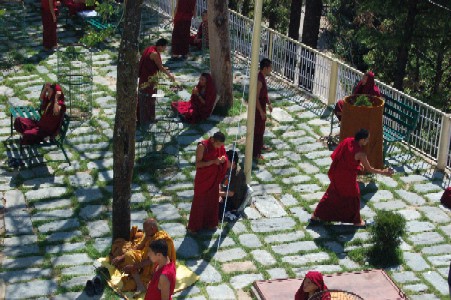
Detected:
left=383, top=95, right=420, bottom=160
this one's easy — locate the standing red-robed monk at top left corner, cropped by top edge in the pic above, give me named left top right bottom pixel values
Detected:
left=41, top=0, right=58, bottom=50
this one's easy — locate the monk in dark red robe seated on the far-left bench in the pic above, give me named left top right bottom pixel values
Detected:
left=14, top=83, right=66, bottom=145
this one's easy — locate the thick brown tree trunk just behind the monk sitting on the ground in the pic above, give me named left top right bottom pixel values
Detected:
left=207, top=0, right=233, bottom=110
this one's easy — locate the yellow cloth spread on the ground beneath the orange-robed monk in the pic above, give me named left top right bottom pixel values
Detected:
left=98, top=257, right=199, bottom=299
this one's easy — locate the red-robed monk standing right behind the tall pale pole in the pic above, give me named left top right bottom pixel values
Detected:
left=252, top=58, right=272, bottom=159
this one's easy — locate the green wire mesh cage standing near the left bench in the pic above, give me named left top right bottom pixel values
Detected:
left=57, top=44, right=93, bottom=119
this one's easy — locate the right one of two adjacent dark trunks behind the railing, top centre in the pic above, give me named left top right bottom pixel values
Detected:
left=302, top=0, right=323, bottom=49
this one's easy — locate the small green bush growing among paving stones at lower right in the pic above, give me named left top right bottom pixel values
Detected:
left=368, top=210, right=406, bottom=266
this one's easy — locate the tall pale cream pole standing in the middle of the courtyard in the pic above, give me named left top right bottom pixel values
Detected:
left=244, top=0, right=263, bottom=184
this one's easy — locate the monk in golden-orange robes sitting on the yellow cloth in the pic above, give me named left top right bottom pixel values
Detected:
left=110, top=219, right=176, bottom=293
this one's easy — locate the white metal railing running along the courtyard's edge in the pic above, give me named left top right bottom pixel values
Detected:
left=155, top=0, right=451, bottom=169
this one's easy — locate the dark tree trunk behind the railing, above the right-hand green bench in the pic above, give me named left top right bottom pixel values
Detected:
left=394, top=0, right=418, bottom=91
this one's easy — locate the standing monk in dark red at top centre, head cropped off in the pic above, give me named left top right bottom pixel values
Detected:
left=172, top=0, right=196, bottom=57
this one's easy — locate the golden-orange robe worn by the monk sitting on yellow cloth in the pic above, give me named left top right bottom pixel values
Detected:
left=112, top=230, right=176, bottom=292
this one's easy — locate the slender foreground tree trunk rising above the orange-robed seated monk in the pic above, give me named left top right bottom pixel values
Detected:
left=113, top=0, right=142, bottom=240
